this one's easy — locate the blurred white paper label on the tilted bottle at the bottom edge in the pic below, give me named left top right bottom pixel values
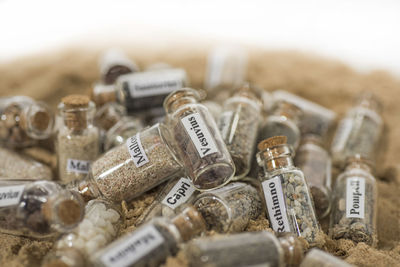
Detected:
left=100, top=225, right=164, bottom=267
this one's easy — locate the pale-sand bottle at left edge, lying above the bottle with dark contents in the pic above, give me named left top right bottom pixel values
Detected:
left=0, top=147, right=53, bottom=180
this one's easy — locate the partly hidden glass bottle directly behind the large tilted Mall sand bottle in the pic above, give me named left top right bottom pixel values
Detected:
left=104, top=116, right=144, bottom=151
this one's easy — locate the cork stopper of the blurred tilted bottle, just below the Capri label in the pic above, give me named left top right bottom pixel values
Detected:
left=172, top=206, right=206, bottom=241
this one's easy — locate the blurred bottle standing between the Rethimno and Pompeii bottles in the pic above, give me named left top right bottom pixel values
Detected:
left=294, top=135, right=332, bottom=219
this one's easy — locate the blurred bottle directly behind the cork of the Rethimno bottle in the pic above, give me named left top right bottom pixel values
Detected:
left=260, top=100, right=302, bottom=150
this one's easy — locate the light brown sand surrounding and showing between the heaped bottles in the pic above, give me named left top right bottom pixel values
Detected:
left=0, top=46, right=400, bottom=267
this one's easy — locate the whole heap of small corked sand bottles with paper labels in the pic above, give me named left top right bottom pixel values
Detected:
left=0, top=48, right=383, bottom=266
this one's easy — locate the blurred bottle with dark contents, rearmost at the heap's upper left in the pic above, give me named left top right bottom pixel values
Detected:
left=99, top=48, right=139, bottom=84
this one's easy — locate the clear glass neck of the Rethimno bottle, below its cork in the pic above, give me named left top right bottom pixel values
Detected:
left=257, top=144, right=294, bottom=172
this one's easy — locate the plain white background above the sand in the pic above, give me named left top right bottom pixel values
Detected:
left=0, top=0, right=400, bottom=75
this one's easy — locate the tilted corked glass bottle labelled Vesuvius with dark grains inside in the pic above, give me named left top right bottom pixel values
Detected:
left=164, top=88, right=235, bottom=190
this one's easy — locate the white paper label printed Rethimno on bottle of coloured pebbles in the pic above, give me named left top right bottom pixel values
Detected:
left=262, top=176, right=290, bottom=233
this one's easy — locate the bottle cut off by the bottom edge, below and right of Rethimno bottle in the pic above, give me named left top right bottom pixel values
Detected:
left=300, top=248, right=353, bottom=267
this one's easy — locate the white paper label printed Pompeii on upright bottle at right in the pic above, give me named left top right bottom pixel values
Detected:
left=346, top=177, right=365, bottom=219
